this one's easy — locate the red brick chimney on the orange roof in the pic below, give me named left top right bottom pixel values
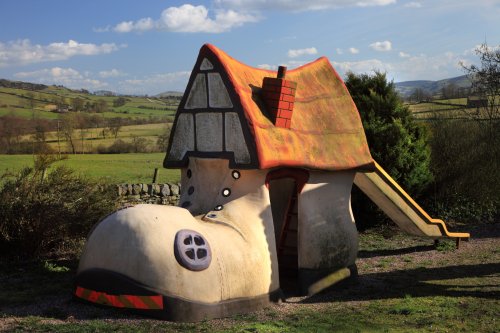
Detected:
left=262, top=66, right=297, bottom=128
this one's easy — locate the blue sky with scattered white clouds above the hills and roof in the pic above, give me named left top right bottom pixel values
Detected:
left=0, top=0, right=500, bottom=95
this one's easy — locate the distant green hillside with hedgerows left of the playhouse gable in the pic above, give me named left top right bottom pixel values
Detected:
left=0, top=79, right=180, bottom=124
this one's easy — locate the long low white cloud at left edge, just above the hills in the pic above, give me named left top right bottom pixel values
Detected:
left=0, top=39, right=125, bottom=67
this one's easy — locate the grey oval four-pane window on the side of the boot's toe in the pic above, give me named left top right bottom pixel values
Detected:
left=174, top=229, right=212, bottom=271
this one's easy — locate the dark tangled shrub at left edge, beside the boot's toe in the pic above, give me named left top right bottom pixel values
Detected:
left=0, top=156, right=117, bottom=257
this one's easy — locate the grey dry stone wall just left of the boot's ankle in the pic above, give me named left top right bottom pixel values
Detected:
left=117, top=183, right=181, bottom=206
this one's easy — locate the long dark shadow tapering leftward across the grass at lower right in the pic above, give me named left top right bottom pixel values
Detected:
left=301, top=263, right=500, bottom=303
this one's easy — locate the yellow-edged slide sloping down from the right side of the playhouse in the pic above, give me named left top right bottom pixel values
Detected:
left=354, top=162, right=470, bottom=239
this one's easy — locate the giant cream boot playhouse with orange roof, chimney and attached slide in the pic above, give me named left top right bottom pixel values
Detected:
left=75, top=45, right=468, bottom=321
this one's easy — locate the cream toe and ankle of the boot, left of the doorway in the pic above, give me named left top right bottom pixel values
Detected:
left=79, top=158, right=279, bottom=303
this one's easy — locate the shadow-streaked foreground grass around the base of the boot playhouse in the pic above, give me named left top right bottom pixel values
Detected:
left=0, top=223, right=500, bottom=333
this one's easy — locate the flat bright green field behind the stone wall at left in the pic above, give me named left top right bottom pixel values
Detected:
left=0, top=153, right=180, bottom=184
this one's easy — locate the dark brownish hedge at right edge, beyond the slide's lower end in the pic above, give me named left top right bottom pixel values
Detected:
left=430, top=117, right=500, bottom=221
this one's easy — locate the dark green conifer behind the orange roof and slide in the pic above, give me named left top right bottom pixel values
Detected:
left=345, top=72, right=432, bottom=228
